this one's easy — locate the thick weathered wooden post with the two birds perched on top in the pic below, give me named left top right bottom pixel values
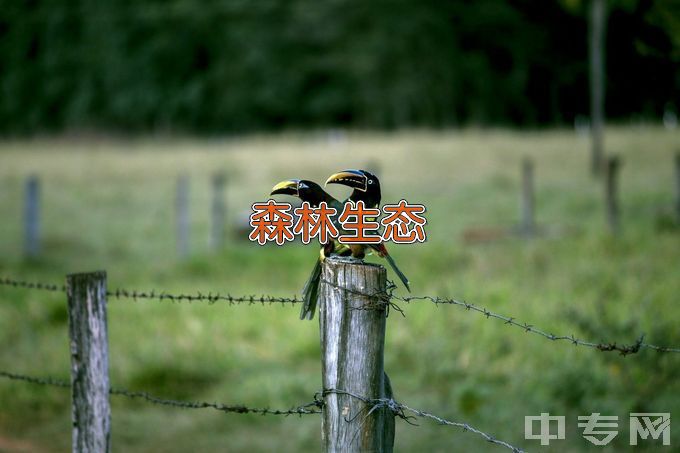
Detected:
left=319, top=257, right=394, bottom=453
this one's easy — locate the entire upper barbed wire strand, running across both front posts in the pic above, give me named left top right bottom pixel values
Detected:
left=0, top=278, right=680, bottom=356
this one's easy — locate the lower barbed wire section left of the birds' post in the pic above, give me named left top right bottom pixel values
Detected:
left=0, top=370, right=322, bottom=415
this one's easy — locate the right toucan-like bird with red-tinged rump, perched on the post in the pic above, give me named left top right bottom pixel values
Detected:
left=326, top=170, right=411, bottom=292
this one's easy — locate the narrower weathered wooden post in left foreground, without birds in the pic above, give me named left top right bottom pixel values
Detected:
left=66, top=271, right=111, bottom=453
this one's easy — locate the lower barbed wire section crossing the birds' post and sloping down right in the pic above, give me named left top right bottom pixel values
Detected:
left=322, top=389, right=524, bottom=453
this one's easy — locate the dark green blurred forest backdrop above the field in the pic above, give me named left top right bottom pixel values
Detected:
left=0, top=0, right=680, bottom=135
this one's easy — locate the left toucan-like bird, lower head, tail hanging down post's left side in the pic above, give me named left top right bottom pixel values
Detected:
left=269, top=179, right=351, bottom=320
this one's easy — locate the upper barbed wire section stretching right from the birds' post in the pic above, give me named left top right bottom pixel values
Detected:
left=391, top=295, right=680, bottom=356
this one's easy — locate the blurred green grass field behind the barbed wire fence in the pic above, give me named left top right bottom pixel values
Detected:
left=0, top=126, right=680, bottom=452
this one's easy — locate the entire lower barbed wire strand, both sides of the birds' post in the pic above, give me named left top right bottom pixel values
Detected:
left=0, top=370, right=524, bottom=453
